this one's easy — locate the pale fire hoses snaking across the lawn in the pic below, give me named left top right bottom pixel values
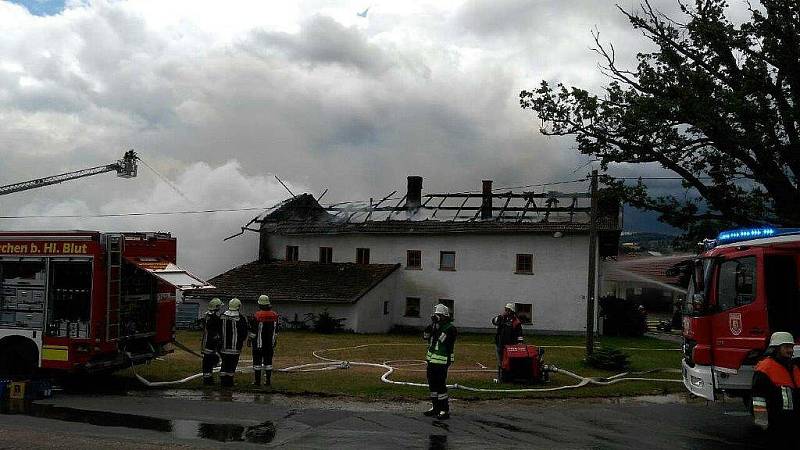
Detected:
left=131, top=342, right=683, bottom=393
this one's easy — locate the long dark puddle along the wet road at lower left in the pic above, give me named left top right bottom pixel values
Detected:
left=0, top=400, right=275, bottom=444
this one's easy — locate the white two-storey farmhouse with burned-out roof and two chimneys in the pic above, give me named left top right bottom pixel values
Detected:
left=185, top=176, right=621, bottom=334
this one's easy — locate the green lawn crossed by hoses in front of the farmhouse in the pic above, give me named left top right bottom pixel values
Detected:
left=115, top=331, right=684, bottom=400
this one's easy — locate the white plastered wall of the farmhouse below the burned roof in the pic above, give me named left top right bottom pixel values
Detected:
left=268, top=234, right=589, bottom=332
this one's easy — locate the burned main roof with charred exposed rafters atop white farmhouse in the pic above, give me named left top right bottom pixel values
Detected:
left=251, top=183, right=621, bottom=234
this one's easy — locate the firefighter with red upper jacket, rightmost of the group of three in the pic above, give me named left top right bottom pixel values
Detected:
left=249, top=295, right=278, bottom=386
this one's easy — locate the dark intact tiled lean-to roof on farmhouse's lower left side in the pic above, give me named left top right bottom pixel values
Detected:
left=184, top=261, right=400, bottom=303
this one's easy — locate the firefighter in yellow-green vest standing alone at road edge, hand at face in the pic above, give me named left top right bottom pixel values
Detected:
left=422, top=304, right=458, bottom=419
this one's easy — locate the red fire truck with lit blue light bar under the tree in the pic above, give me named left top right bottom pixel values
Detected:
left=682, top=227, right=800, bottom=406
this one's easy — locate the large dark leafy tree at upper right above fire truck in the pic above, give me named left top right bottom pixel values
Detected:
left=520, top=0, right=800, bottom=243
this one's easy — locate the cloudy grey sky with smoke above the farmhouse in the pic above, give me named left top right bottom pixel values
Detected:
left=0, top=0, right=743, bottom=276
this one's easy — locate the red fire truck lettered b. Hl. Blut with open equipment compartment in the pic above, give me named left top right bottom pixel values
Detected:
left=0, top=231, right=210, bottom=377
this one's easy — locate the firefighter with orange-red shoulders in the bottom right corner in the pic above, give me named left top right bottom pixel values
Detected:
left=752, top=331, right=800, bottom=443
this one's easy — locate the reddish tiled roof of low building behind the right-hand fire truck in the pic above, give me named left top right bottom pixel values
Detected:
left=603, top=255, right=693, bottom=288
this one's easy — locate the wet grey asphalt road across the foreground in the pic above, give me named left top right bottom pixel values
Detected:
left=0, top=391, right=765, bottom=450
